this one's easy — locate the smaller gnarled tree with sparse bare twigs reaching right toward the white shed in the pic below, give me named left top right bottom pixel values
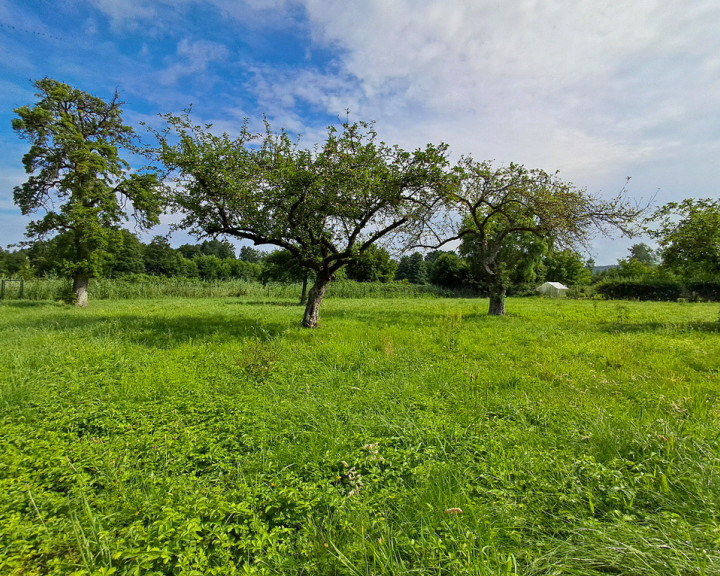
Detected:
left=445, top=158, right=642, bottom=315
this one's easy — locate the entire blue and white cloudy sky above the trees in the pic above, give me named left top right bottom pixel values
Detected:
left=0, top=0, right=720, bottom=264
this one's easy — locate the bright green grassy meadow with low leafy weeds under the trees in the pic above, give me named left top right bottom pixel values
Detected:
left=0, top=298, right=720, bottom=576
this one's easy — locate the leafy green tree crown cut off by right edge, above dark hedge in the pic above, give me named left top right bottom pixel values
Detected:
left=648, top=198, right=720, bottom=278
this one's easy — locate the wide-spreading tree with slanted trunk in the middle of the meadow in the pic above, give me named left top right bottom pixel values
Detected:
left=157, top=116, right=453, bottom=327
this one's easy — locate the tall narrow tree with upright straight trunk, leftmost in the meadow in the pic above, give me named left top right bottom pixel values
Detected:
left=12, top=78, right=160, bottom=306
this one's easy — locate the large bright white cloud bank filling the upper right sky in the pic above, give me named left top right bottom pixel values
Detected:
left=284, top=0, right=720, bottom=184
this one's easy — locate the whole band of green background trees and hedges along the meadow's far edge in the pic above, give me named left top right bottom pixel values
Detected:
left=0, top=214, right=720, bottom=300
